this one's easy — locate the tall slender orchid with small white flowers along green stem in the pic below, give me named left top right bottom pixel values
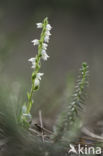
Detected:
left=19, top=18, right=52, bottom=126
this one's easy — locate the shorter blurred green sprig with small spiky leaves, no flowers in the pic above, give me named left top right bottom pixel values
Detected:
left=53, top=63, right=88, bottom=142
